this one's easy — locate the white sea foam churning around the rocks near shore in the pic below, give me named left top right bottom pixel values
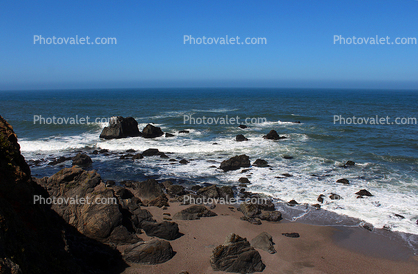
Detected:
left=20, top=126, right=418, bottom=234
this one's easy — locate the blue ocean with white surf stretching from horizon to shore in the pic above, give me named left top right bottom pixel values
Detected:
left=0, top=88, right=418, bottom=241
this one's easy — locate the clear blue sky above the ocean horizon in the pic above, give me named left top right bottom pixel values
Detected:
left=0, top=0, right=418, bottom=90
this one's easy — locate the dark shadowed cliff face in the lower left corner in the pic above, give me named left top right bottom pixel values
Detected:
left=0, top=116, right=127, bottom=274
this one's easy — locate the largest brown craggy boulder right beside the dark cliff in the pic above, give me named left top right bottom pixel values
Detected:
left=44, top=166, right=122, bottom=241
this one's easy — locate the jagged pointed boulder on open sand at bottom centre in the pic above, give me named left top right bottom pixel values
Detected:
left=210, top=233, right=266, bottom=273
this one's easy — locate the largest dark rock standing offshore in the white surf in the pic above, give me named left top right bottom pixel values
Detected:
left=100, top=116, right=141, bottom=139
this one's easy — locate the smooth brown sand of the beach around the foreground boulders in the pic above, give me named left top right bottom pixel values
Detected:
left=123, top=203, right=418, bottom=274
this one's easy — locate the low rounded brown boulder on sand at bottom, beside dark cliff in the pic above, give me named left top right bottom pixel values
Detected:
left=123, top=239, right=175, bottom=265
